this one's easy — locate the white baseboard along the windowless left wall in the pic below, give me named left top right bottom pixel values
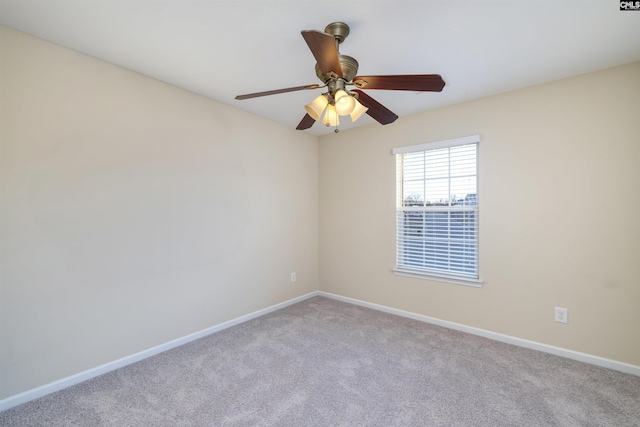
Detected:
left=0, top=291, right=318, bottom=412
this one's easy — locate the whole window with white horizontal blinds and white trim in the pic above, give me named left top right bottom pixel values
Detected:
left=393, top=135, right=482, bottom=286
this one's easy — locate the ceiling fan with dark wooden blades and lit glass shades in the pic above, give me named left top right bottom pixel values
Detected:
left=236, top=22, right=445, bottom=132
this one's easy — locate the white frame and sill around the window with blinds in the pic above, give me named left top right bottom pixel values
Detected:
left=392, top=135, right=483, bottom=287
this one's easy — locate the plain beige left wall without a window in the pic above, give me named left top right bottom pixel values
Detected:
left=0, top=27, right=318, bottom=399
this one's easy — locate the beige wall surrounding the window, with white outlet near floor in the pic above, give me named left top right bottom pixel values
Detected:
left=320, top=63, right=640, bottom=365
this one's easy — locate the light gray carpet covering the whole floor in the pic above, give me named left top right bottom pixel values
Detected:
left=0, top=297, right=640, bottom=426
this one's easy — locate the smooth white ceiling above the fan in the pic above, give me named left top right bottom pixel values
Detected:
left=0, top=0, right=640, bottom=135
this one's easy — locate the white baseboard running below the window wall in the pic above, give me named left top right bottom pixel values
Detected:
left=318, top=291, right=640, bottom=376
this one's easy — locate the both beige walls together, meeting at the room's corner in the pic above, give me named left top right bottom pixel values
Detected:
left=0, top=21, right=640, bottom=399
